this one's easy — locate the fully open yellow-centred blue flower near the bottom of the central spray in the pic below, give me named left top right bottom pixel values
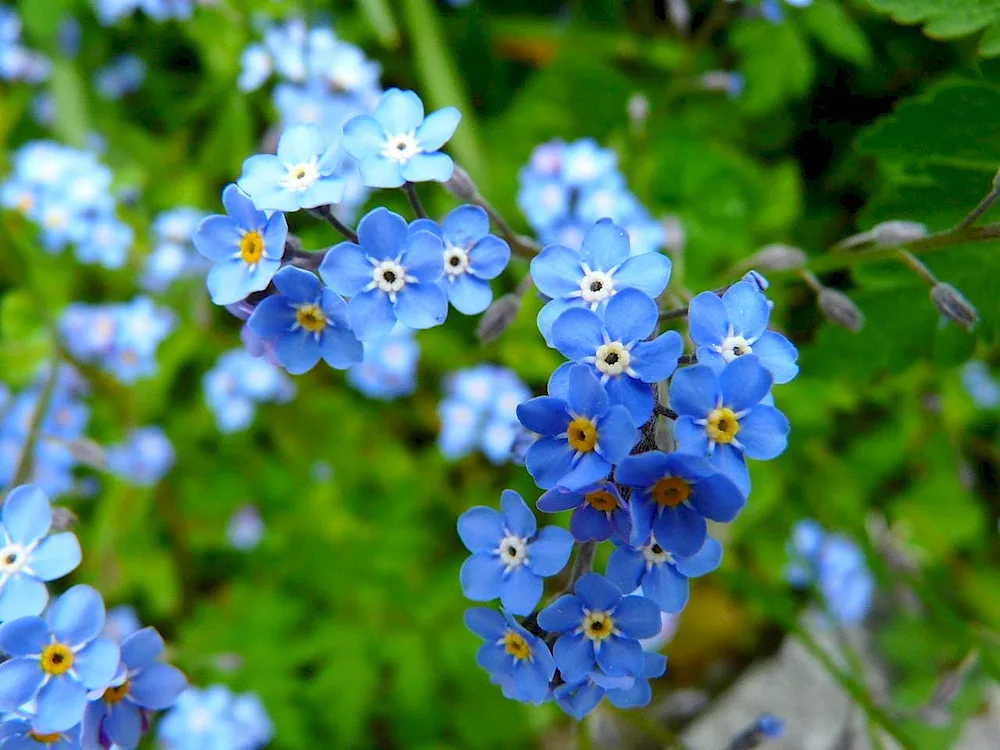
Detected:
left=538, top=573, right=660, bottom=682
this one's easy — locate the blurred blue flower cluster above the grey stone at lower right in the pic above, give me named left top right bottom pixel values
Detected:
left=785, top=519, right=875, bottom=625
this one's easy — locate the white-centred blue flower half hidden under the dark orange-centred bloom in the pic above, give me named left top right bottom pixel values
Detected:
left=606, top=535, right=722, bottom=614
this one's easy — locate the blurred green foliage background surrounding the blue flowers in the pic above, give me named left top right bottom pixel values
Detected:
left=0, top=0, right=1000, bottom=750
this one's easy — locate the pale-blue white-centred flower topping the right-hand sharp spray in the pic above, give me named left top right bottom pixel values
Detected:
left=531, top=219, right=670, bottom=346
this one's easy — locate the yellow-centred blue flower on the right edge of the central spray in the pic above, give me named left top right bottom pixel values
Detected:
left=670, top=354, right=790, bottom=495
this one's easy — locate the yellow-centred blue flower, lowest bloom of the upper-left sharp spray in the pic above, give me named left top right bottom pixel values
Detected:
left=247, top=266, right=362, bottom=375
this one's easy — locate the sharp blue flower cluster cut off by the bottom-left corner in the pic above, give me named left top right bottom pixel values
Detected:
left=0, top=485, right=186, bottom=750
